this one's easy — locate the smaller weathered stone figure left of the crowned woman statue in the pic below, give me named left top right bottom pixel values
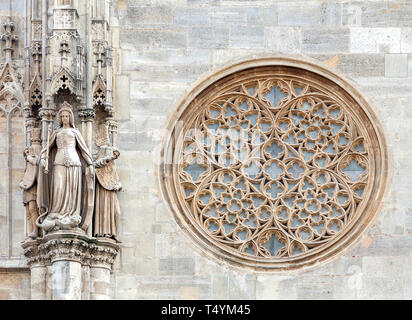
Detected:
left=20, top=128, right=41, bottom=239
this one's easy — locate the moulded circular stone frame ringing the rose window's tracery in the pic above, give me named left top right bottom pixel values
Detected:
left=158, top=56, right=389, bottom=271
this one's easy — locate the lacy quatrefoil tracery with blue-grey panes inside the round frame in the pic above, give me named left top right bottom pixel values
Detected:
left=178, top=76, right=370, bottom=258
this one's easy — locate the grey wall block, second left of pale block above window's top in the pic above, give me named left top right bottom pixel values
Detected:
left=188, top=25, right=229, bottom=49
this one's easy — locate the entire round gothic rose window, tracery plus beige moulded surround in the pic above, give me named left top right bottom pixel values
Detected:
left=161, top=60, right=386, bottom=269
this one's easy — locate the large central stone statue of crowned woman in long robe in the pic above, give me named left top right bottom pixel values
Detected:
left=37, top=102, right=94, bottom=232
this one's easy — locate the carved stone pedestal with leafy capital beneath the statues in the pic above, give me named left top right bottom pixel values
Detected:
left=22, top=231, right=119, bottom=300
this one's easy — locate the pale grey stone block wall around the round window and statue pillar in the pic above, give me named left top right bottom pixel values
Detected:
left=0, top=0, right=412, bottom=299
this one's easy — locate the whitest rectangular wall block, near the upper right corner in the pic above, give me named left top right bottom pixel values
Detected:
left=350, top=28, right=401, bottom=53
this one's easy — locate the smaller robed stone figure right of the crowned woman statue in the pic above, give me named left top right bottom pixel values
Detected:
left=93, top=125, right=121, bottom=241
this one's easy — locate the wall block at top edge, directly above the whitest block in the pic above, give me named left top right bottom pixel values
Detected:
left=342, top=1, right=389, bottom=28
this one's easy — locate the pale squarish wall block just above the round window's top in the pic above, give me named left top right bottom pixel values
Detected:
left=265, top=27, right=302, bottom=53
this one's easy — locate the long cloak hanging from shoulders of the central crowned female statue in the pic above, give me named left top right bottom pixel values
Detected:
left=37, top=128, right=94, bottom=231
